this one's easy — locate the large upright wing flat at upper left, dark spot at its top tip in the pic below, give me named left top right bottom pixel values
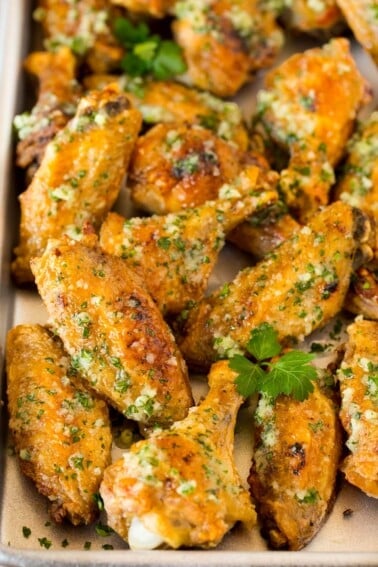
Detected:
left=12, top=86, right=141, bottom=282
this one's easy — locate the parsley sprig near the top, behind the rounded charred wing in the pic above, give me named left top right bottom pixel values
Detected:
left=114, top=18, right=187, bottom=80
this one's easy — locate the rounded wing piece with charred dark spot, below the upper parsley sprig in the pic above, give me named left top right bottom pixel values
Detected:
left=128, top=122, right=254, bottom=214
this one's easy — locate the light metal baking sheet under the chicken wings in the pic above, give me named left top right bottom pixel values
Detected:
left=0, top=0, right=378, bottom=567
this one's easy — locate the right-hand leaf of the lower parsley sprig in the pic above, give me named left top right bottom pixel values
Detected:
left=261, top=350, right=317, bottom=401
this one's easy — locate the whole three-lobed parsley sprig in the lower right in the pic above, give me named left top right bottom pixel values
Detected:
left=229, top=323, right=317, bottom=401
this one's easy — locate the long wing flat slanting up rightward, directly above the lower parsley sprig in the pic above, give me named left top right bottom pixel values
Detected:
left=180, top=201, right=371, bottom=366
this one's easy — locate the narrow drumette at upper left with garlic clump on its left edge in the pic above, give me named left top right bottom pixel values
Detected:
left=15, top=47, right=81, bottom=181
